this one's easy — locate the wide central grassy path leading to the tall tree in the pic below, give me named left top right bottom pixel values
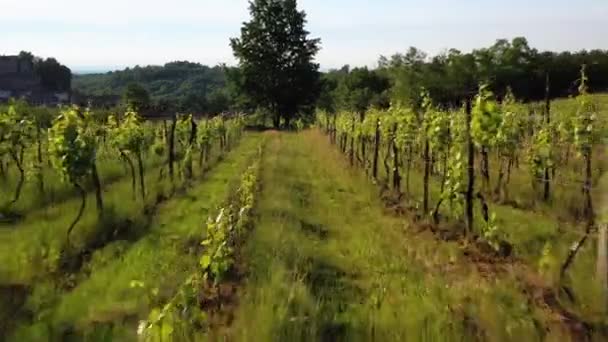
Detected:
left=224, top=132, right=563, bottom=341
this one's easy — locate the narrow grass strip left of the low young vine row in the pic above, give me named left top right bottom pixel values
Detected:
left=5, top=134, right=260, bottom=340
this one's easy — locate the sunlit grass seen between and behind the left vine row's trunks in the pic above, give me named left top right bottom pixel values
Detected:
left=0, top=162, right=167, bottom=285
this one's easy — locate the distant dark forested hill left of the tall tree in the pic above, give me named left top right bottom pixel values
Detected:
left=72, top=62, right=228, bottom=111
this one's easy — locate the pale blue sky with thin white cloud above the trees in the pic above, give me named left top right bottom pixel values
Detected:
left=0, top=0, right=608, bottom=71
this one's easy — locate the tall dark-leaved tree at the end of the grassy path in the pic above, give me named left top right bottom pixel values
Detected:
left=230, top=0, right=320, bottom=128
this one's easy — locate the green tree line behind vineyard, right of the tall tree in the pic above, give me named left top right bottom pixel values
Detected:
left=317, top=37, right=608, bottom=111
